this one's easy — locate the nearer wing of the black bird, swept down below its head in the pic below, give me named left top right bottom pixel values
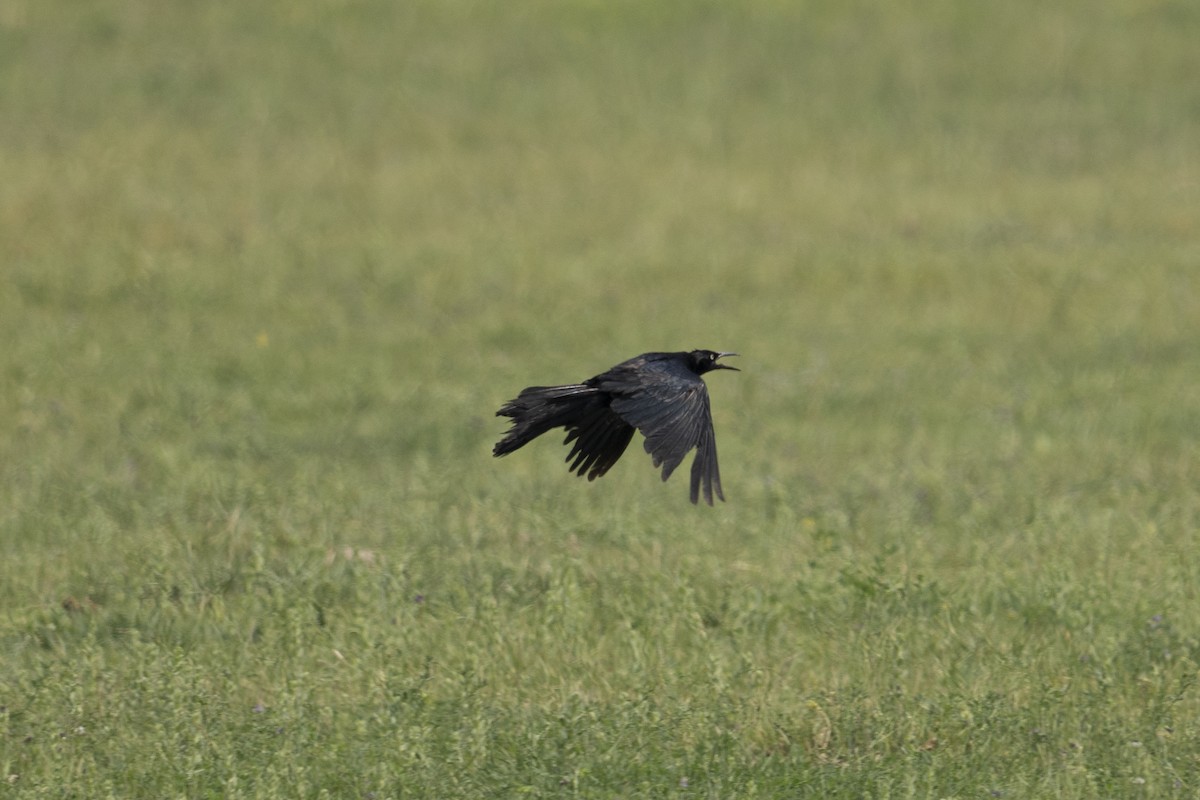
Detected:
left=601, top=362, right=725, bottom=505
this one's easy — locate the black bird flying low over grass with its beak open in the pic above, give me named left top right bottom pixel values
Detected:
left=492, top=350, right=738, bottom=505
